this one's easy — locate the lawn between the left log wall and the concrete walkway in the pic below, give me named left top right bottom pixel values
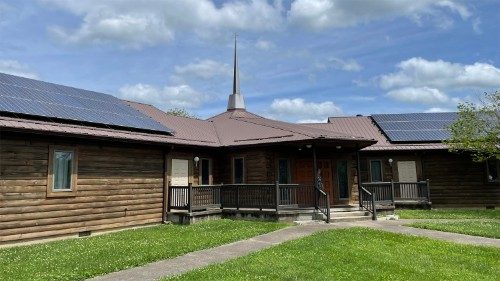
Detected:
left=0, top=220, right=287, bottom=281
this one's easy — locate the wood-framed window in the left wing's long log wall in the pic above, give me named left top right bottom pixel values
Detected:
left=47, top=146, right=77, bottom=196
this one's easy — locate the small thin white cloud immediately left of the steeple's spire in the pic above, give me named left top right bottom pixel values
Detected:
left=174, top=59, right=232, bottom=79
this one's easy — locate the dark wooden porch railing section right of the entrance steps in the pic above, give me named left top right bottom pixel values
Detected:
left=361, top=180, right=431, bottom=205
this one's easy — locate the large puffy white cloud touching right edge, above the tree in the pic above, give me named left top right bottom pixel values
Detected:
left=380, top=58, right=500, bottom=90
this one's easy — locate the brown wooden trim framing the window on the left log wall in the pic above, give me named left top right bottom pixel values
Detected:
left=47, top=145, right=78, bottom=197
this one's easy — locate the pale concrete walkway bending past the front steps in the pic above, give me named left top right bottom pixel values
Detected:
left=90, top=220, right=500, bottom=281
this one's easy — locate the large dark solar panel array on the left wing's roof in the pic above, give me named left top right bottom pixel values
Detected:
left=0, top=73, right=173, bottom=133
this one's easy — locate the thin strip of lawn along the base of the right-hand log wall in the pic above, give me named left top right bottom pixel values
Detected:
left=396, top=209, right=500, bottom=219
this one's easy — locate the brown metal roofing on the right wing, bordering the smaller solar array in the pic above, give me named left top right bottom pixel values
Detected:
left=307, top=116, right=448, bottom=151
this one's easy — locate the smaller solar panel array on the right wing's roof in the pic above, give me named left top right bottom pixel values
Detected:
left=372, top=112, right=457, bottom=142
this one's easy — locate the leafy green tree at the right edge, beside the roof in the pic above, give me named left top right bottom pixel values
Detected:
left=445, top=91, right=500, bottom=162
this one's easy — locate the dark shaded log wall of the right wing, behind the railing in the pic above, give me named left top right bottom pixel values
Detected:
left=360, top=150, right=500, bottom=207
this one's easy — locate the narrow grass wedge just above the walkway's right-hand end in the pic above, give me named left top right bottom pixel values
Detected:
left=407, top=220, right=500, bottom=239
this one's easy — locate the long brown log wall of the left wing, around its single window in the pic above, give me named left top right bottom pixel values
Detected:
left=0, top=133, right=164, bottom=243
